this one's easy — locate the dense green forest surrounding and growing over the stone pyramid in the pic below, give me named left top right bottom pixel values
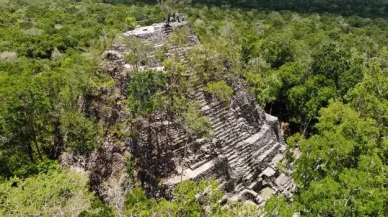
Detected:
left=0, top=0, right=388, bottom=217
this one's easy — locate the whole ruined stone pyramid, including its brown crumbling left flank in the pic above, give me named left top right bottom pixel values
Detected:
left=61, top=21, right=295, bottom=205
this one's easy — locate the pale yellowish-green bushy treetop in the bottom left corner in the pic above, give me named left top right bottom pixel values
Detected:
left=0, top=169, right=93, bottom=216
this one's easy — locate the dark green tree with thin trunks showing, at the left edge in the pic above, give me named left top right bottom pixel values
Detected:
left=0, top=76, right=51, bottom=162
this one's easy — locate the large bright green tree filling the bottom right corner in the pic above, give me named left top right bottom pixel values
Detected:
left=294, top=102, right=388, bottom=216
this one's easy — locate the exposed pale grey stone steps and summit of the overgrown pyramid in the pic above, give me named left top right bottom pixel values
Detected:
left=116, top=22, right=295, bottom=205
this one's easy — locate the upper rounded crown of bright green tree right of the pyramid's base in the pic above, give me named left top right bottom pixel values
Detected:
left=296, top=102, right=379, bottom=186
